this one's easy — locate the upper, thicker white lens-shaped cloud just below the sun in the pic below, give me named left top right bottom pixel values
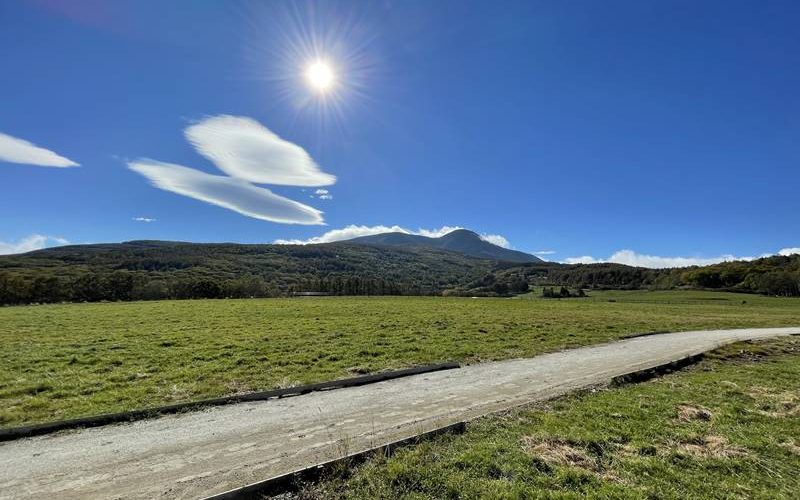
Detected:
left=185, top=115, right=336, bottom=186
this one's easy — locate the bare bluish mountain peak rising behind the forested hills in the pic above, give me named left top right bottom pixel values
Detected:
left=347, top=229, right=543, bottom=263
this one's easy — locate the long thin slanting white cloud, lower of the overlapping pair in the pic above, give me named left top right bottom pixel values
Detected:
left=128, top=159, right=324, bottom=224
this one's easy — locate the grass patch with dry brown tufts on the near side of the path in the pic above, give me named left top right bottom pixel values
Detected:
left=304, top=337, right=800, bottom=499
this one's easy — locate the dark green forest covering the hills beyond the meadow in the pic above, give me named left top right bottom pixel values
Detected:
left=0, top=241, right=800, bottom=305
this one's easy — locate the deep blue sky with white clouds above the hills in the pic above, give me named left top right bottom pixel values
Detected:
left=0, top=0, right=800, bottom=265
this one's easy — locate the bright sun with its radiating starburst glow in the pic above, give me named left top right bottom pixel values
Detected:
left=240, top=2, right=387, bottom=139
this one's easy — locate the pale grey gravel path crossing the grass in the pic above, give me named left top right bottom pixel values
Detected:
left=0, top=327, right=800, bottom=499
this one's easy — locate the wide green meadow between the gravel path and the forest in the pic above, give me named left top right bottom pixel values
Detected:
left=0, top=292, right=800, bottom=427
